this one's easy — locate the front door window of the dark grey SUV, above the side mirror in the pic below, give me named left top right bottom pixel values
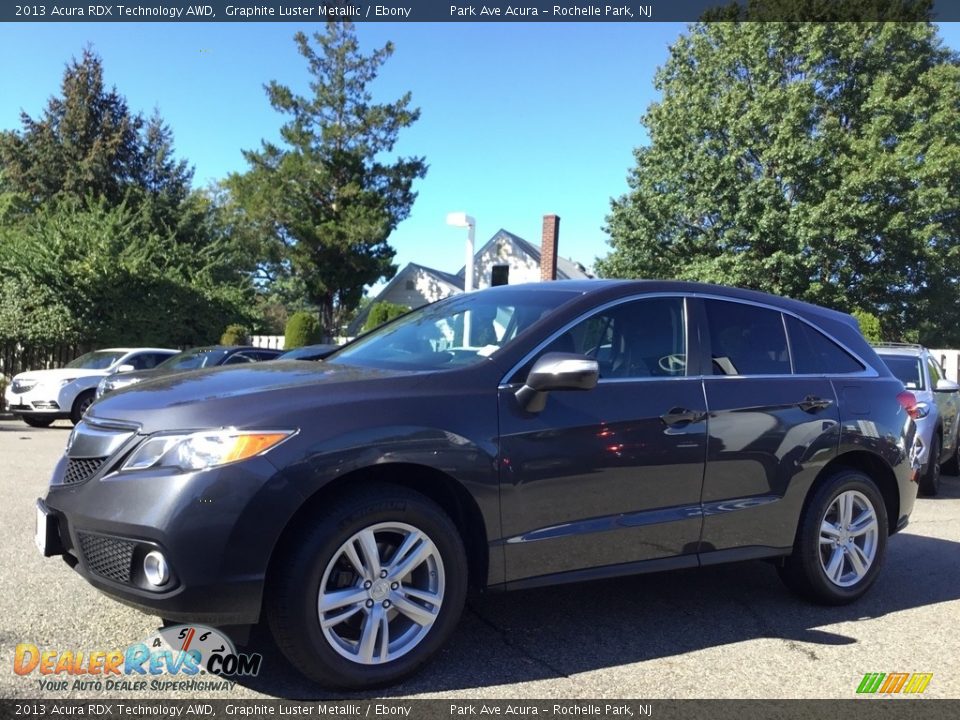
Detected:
left=541, top=298, right=687, bottom=378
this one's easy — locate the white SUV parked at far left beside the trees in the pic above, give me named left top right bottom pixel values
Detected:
left=4, top=348, right=177, bottom=427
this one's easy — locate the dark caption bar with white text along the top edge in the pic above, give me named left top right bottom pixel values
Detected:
left=0, top=0, right=960, bottom=23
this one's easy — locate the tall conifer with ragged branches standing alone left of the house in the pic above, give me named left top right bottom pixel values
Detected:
left=229, top=22, right=426, bottom=344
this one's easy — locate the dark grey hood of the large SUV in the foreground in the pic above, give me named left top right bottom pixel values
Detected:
left=87, top=360, right=425, bottom=432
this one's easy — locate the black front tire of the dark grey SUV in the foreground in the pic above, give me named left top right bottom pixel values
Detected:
left=266, top=484, right=467, bottom=690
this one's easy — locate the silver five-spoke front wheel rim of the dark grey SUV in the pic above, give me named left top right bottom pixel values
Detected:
left=317, top=522, right=446, bottom=665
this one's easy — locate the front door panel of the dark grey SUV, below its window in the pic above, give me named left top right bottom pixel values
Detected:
left=500, top=379, right=706, bottom=581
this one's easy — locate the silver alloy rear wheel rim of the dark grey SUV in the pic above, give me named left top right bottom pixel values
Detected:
left=820, top=490, right=880, bottom=587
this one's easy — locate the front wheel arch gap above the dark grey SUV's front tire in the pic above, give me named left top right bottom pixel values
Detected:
left=267, top=462, right=489, bottom=589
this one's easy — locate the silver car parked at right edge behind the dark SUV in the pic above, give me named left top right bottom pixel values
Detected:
left=874, top=343, right=960, bottom=495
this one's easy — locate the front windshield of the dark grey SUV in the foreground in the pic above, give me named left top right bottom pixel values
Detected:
left=327, top=287, right=578, bottom=370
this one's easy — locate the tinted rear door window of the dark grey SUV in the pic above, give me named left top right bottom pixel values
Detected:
left=705, top=300, right=790, bottom=375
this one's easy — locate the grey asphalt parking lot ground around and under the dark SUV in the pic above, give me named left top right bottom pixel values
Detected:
left=0, top=420, right=960, bottom=699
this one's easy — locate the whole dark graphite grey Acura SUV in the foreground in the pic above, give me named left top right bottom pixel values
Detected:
left=37, top=281, right=919, bottom=688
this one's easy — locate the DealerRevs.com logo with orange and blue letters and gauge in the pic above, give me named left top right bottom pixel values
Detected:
left=13, top=625, right=263, bottom=692
